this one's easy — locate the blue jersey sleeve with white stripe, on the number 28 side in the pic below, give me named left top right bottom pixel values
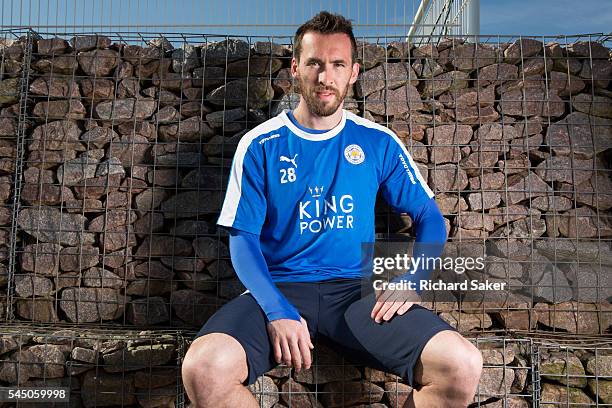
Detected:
left=217, top=145, right=266, bottom=235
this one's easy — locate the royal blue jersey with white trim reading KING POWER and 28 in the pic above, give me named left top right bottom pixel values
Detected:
left=217, top=110, right=433, bottom=282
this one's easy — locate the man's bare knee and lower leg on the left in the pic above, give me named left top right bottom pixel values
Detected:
left=182, top=333, right=258, bottom=408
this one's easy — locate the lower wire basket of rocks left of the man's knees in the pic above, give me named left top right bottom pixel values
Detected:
left=0, top=325, right=184, bottom=407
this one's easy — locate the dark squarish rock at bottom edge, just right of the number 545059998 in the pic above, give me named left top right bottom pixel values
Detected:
left=81, top=370, right=136, bottom=408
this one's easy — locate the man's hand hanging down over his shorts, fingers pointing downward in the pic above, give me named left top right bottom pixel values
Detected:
left=268, top=317, right=314, bottom=373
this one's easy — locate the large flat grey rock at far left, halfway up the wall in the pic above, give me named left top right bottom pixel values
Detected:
left=17, top=206, right=93, bottom=246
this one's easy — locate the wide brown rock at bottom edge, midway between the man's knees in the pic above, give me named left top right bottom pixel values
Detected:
left=321, top=381, right=384, bottom=407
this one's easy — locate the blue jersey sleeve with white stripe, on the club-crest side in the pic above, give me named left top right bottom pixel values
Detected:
left=381, top=135, right=434, bottom=215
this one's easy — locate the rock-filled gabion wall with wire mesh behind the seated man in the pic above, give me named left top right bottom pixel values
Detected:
left=0, top=34, right=612, bottom=407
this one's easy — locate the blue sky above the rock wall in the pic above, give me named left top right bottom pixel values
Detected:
left=0, top=0, right=612, bottom=37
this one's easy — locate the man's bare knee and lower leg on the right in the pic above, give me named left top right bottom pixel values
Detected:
left=404, top=330, right=482, bottom=408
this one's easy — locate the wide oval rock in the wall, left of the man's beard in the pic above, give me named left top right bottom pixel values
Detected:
left=206, top=78, right=274, bottom=108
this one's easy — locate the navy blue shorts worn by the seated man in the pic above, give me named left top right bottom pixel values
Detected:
left=197, top=279, right=456, bottom=387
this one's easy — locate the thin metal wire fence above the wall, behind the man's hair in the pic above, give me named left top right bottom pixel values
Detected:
left=0, top=0, right=462, bottom=37
